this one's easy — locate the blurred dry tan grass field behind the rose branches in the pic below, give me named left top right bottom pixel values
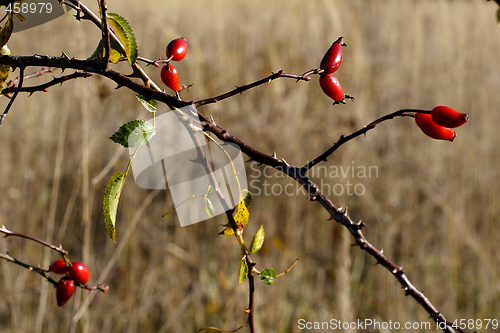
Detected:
left=0, top=0, right=500, bottom=333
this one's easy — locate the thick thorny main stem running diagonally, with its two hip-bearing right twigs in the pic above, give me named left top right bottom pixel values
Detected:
left=0, top=50, right=462, bottom=333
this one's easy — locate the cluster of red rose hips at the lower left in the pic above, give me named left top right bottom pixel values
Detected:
left=49, top=259, right=90, bottom=306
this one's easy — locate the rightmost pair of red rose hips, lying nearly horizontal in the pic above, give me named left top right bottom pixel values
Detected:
left=415, top=106, right=469, bottom=141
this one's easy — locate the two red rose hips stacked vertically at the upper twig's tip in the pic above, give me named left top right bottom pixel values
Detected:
left=319, top=37, right=352, bottom=104
